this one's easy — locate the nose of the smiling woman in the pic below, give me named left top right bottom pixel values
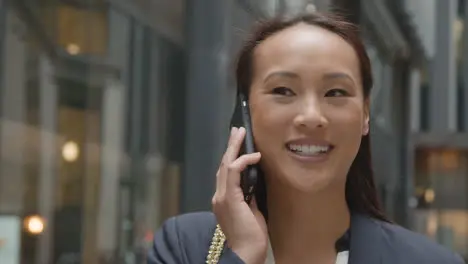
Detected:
left=294, top=100, right=328, bottom=129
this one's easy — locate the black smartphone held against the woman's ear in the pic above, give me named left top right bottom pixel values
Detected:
left=231, top=93, right=258, bottom=204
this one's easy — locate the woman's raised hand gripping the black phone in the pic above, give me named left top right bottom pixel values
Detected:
left=212, top=128, right=268, bottom=264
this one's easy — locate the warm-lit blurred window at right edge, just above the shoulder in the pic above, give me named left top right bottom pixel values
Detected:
left=413, top=148, right=468, bottom=258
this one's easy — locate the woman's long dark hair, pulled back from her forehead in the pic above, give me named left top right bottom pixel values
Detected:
left=236, top=13, right=388, bottom=221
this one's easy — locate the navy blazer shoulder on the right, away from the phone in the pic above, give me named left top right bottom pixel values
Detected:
left=376, top=221, right=465, bottom=264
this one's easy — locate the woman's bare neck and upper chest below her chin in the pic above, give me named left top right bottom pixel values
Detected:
left=267, top=184, right=350, bottom=263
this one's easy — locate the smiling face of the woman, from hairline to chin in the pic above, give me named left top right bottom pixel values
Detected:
left=250, top=24, right=369, bottom=192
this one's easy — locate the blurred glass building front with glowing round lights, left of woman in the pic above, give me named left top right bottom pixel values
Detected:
left=0, top=0, right=185, bottom=264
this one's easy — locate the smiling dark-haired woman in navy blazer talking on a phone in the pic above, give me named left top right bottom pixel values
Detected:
left=148, top=10, right=463, bottom=264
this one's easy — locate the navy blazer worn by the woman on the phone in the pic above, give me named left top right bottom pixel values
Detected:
left=148, top=212, right=465, bottom=264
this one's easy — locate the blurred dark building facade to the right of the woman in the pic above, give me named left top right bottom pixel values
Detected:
left=335, top=0, right=468, bottom=258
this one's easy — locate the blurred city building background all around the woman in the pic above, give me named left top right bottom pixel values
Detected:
left=0, top=0, right=468, bottom=264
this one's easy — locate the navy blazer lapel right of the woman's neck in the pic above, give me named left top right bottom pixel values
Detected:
left=349, top=214, right=385, bottom=264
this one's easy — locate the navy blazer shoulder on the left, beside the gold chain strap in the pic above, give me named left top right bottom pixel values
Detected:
left=148, top=212, right=216, bottom=264
